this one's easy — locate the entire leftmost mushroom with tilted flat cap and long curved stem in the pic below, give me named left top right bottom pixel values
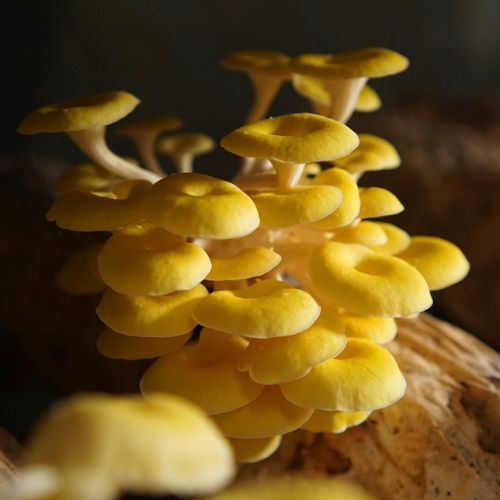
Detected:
left=17, top=91, right=159, bottom=182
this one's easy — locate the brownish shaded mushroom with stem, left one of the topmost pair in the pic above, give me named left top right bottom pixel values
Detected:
left=222, top=50, right=292, bottom=123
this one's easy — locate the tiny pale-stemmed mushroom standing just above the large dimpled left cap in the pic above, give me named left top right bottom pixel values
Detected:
left=157, top=132, right=215, bottom=173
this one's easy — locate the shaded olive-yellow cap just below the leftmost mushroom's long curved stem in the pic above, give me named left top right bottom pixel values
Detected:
left=47, top=179, right=151, bottom=232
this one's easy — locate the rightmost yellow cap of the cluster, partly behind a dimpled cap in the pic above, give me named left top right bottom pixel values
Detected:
left=397, top=236, right=470, bottom=290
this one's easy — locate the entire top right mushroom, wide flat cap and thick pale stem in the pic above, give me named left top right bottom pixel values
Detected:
left=290, top=47, right=408, bottom=122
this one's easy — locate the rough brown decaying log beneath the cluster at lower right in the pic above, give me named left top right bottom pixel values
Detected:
left=239, top=315, right=500, bottom=500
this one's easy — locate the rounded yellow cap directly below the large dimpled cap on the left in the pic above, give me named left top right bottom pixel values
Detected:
left=97, top=226, right=212, bottom=295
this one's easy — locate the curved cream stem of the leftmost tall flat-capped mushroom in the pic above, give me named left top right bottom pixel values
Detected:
left=68, top=126, right=161, bottom=182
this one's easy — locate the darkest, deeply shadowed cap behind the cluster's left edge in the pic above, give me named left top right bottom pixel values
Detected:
left=55, top=243, right=106, bottom=295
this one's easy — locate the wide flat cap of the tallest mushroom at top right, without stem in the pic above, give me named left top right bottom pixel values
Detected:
left=290, top=47, right=408, bottom=80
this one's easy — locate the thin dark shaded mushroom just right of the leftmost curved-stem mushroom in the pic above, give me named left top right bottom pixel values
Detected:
left=117, top=116, right=182, bottom=177
